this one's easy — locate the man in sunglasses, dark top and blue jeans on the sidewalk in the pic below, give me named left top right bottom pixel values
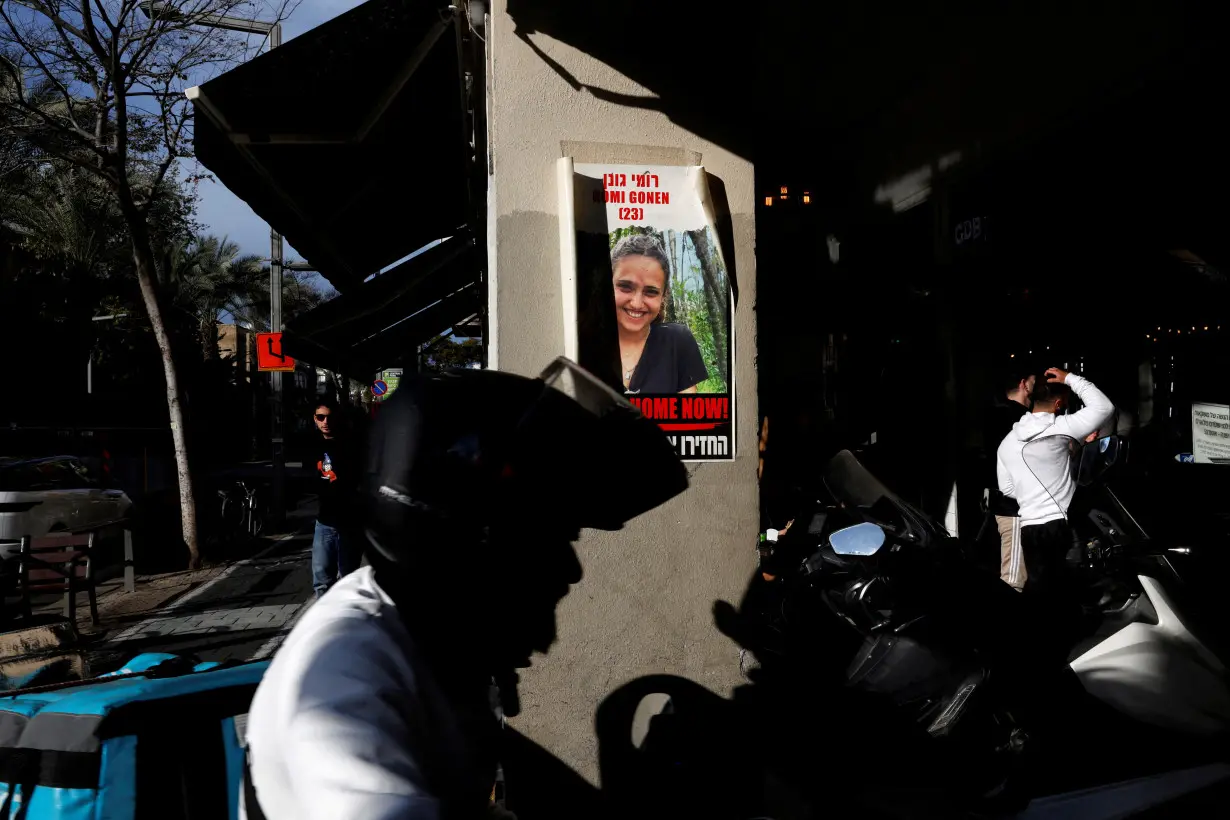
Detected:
left=311, top=398, right=363, bottom=597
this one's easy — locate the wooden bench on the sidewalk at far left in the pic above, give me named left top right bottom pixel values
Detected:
left=17, top=532, right=98, bottom=623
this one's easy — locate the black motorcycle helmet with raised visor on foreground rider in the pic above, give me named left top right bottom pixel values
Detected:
left=363, top=358, right=688, bottom=563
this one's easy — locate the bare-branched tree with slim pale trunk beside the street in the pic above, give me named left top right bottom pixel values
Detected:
left=0, top=0, right=302, bottom=562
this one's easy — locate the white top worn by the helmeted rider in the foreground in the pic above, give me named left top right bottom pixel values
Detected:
left=240, top=567, right=496, bottom=820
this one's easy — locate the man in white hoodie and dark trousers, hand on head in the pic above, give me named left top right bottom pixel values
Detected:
left=996, top=368, right=1114, bottom=595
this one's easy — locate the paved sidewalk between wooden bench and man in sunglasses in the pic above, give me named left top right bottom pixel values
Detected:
left=41, top=504, right=315, bottom=675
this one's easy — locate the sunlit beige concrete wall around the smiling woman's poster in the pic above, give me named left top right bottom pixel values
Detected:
left=487, top=1, right=758, bottom=782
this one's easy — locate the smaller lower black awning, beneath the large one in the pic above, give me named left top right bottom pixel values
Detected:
left=283, top=237, right=482, bottom=375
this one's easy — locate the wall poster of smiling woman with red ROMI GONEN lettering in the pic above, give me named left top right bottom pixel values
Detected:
left=558, top=159, right=734, bottom=461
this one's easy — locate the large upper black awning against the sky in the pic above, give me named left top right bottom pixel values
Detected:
left=188, top=0, right=472, bottom=291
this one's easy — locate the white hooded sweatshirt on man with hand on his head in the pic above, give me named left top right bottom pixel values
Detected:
left=996, top=374, right=1114, bottom=527
